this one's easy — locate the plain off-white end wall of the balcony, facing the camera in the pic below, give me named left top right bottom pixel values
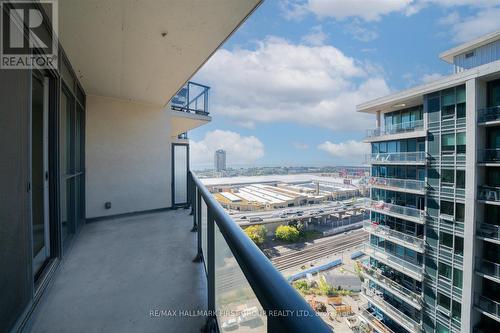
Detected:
left=85, top=96, right=172, bottom=218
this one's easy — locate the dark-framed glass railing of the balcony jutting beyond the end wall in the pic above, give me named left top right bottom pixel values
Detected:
left=170, top=81, right=210, bottom=116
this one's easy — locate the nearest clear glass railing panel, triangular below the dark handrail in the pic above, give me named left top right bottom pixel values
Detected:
left=215, top=220, right=267, bottom=333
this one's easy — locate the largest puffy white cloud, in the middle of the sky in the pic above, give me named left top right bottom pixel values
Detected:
left=196, top=37, right=389, bottom=131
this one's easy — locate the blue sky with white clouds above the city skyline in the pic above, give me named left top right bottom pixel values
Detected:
left=189, top=0, right=500, bottom=169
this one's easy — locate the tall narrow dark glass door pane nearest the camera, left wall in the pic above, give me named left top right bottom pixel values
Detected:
left=31, top=72, right=50, bottom=276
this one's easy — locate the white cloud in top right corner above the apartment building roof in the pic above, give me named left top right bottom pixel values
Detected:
left=440, top=8, right=500, bottom=43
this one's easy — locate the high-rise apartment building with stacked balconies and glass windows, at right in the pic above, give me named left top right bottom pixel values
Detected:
left=357, top=31, right=500, bottom=333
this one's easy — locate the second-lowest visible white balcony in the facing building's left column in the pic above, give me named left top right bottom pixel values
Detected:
left=361, top=286, right=422, bottom=333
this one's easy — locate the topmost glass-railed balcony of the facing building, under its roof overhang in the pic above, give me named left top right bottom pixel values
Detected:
left=364, top=120, right=427, bottom=142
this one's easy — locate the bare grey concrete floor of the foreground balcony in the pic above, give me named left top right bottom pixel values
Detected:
left=28, top=209, right=207, bottom=333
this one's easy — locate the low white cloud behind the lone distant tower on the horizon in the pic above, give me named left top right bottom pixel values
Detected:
left=189, top=130, right=264, bottom=165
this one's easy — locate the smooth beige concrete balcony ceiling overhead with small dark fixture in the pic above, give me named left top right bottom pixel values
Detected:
left=58, top=0, right=261, bottom=106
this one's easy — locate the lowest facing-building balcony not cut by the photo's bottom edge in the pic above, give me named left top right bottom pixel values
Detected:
left=363, top=265, right=422, bottom=310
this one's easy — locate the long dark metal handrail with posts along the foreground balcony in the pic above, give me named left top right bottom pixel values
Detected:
left=188, top=172, right=332, bottom=333
